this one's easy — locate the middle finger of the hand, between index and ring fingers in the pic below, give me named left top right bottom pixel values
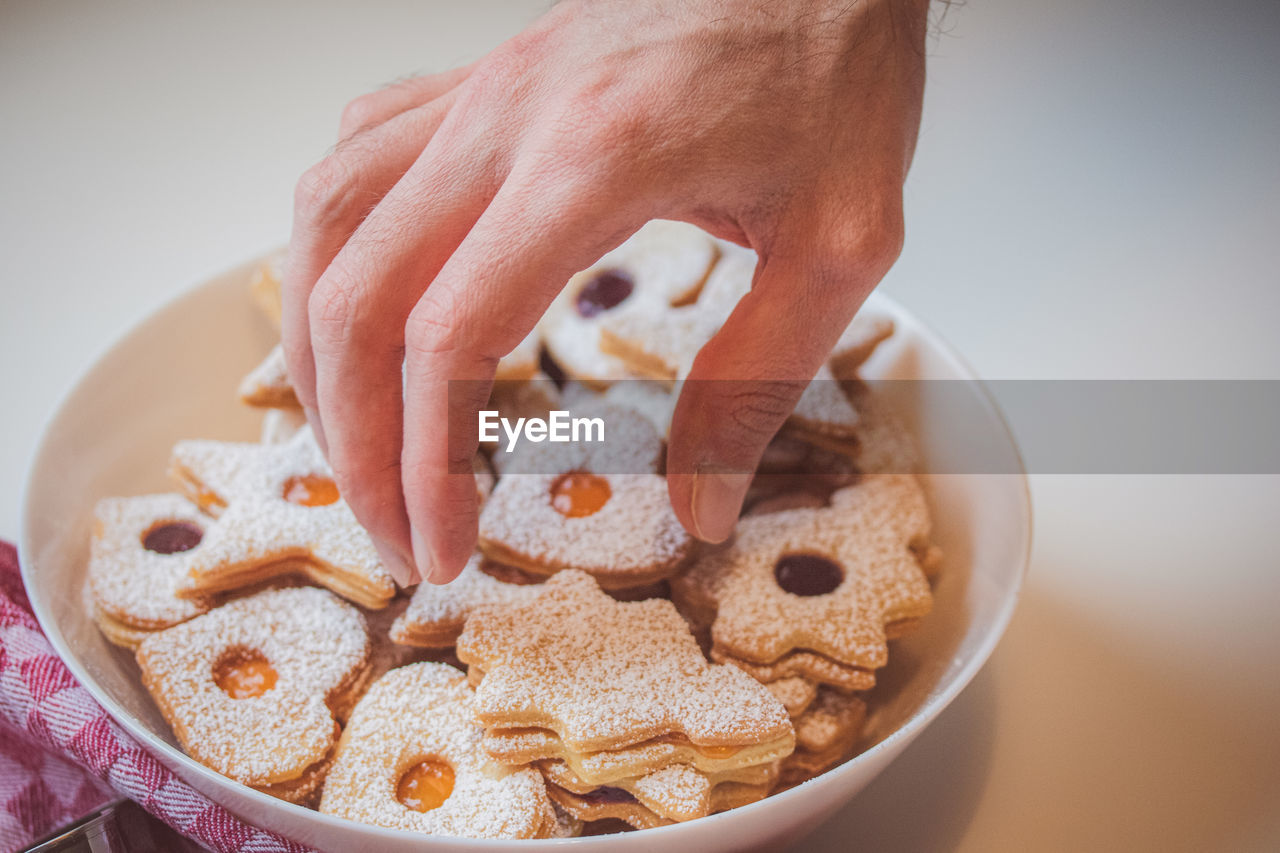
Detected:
left=307, top=108, right=497, bottom=584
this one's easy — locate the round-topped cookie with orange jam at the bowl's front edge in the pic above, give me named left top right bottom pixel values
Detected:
left=320, top=663, right=558, bottom=839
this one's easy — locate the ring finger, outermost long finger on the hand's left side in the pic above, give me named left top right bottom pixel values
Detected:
left=280, top=93, right=454, bottom=447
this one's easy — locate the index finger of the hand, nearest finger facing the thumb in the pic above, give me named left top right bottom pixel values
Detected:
left=403, top=163, right=643, bottom=583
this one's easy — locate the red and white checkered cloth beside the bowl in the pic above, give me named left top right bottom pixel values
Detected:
left=0, top=542, right=307, bottom=853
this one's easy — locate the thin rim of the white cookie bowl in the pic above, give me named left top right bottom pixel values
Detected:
left=18, top=248, right=1033, bottom=850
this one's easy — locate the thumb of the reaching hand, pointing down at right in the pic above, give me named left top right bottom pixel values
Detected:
left=667, top=201, right=901, bottom=542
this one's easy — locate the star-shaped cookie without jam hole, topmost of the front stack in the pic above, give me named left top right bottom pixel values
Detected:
left=457, top=571, right=794, bottom=784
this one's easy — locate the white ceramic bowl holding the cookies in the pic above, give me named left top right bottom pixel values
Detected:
left=22, top=253, right=1030, bottom=853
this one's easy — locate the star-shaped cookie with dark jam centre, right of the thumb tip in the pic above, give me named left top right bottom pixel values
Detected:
left=672, top=474, right=932, bottom=689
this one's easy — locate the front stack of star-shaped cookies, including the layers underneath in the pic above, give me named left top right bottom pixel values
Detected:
left=457, top=570, right=795, bottom=829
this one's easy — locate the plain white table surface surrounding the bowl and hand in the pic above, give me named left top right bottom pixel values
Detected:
left=0, top=0, right=1280, bottom=850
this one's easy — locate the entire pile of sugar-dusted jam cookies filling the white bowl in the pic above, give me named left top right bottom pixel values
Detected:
left=86, top=222, right=940, bottom=839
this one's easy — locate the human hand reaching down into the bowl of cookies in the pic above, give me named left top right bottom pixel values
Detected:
left=283, top=0, right=928, bottom=584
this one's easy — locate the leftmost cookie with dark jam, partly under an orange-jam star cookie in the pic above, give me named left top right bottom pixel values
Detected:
left=88, top=494, right=214, bottom=648
